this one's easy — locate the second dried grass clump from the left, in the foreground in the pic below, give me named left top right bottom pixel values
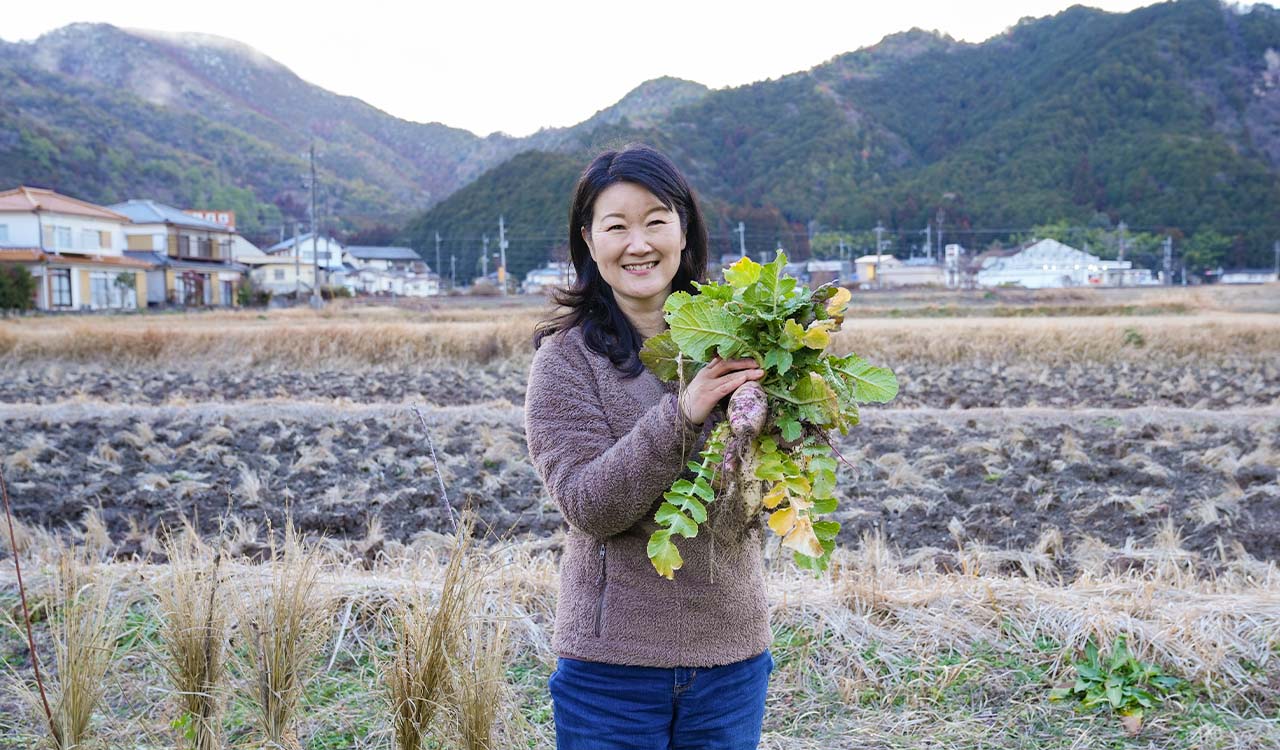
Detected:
left=155, top=526, right=230, bottom=750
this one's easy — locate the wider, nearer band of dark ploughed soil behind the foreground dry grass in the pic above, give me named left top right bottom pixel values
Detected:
left=0, top=402, right=1280, bottom=566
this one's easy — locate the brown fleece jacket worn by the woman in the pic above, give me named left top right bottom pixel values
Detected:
left=525, top=328, right=771, bottom=667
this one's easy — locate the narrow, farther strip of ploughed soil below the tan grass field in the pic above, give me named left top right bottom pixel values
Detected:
left=0, top=357, right=1280, bottom=410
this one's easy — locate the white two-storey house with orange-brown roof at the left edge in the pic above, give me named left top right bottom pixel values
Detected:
left=0, top=187, right=151, bottom=311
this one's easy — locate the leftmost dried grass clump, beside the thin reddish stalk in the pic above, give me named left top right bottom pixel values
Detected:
left=17, top=549, right=123, bottom=750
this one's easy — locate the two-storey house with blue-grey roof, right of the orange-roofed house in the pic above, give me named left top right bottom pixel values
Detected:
left=110, top=200, right=248, bottom=307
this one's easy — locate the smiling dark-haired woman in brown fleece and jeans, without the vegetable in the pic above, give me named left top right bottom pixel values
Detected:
left=525, top=146, right=773, bottom=750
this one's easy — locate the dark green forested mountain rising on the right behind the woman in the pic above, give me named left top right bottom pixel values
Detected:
left=410, top=0, right=1280, bottom=280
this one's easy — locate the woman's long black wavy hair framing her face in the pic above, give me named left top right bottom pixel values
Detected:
left=534, top=143, right=707, bottom=378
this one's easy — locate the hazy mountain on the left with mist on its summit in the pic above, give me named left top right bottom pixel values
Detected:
left=0, top=23, right=707, bottom=240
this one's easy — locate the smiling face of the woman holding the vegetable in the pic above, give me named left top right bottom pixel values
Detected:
left=582, top=182, right=685, bottom=307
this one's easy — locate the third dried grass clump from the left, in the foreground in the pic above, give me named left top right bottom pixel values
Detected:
left=239, top=520, right=329, bottom=750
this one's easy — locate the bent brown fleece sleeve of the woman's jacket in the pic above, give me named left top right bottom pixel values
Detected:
left=525, top=342, right=701, bottom=539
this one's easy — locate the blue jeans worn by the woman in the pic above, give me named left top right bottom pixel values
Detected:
left=549, top=650, right=773, bottom=750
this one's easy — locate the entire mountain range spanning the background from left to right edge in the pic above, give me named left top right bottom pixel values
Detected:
left=0, top=0, right=1280, bottom=271
